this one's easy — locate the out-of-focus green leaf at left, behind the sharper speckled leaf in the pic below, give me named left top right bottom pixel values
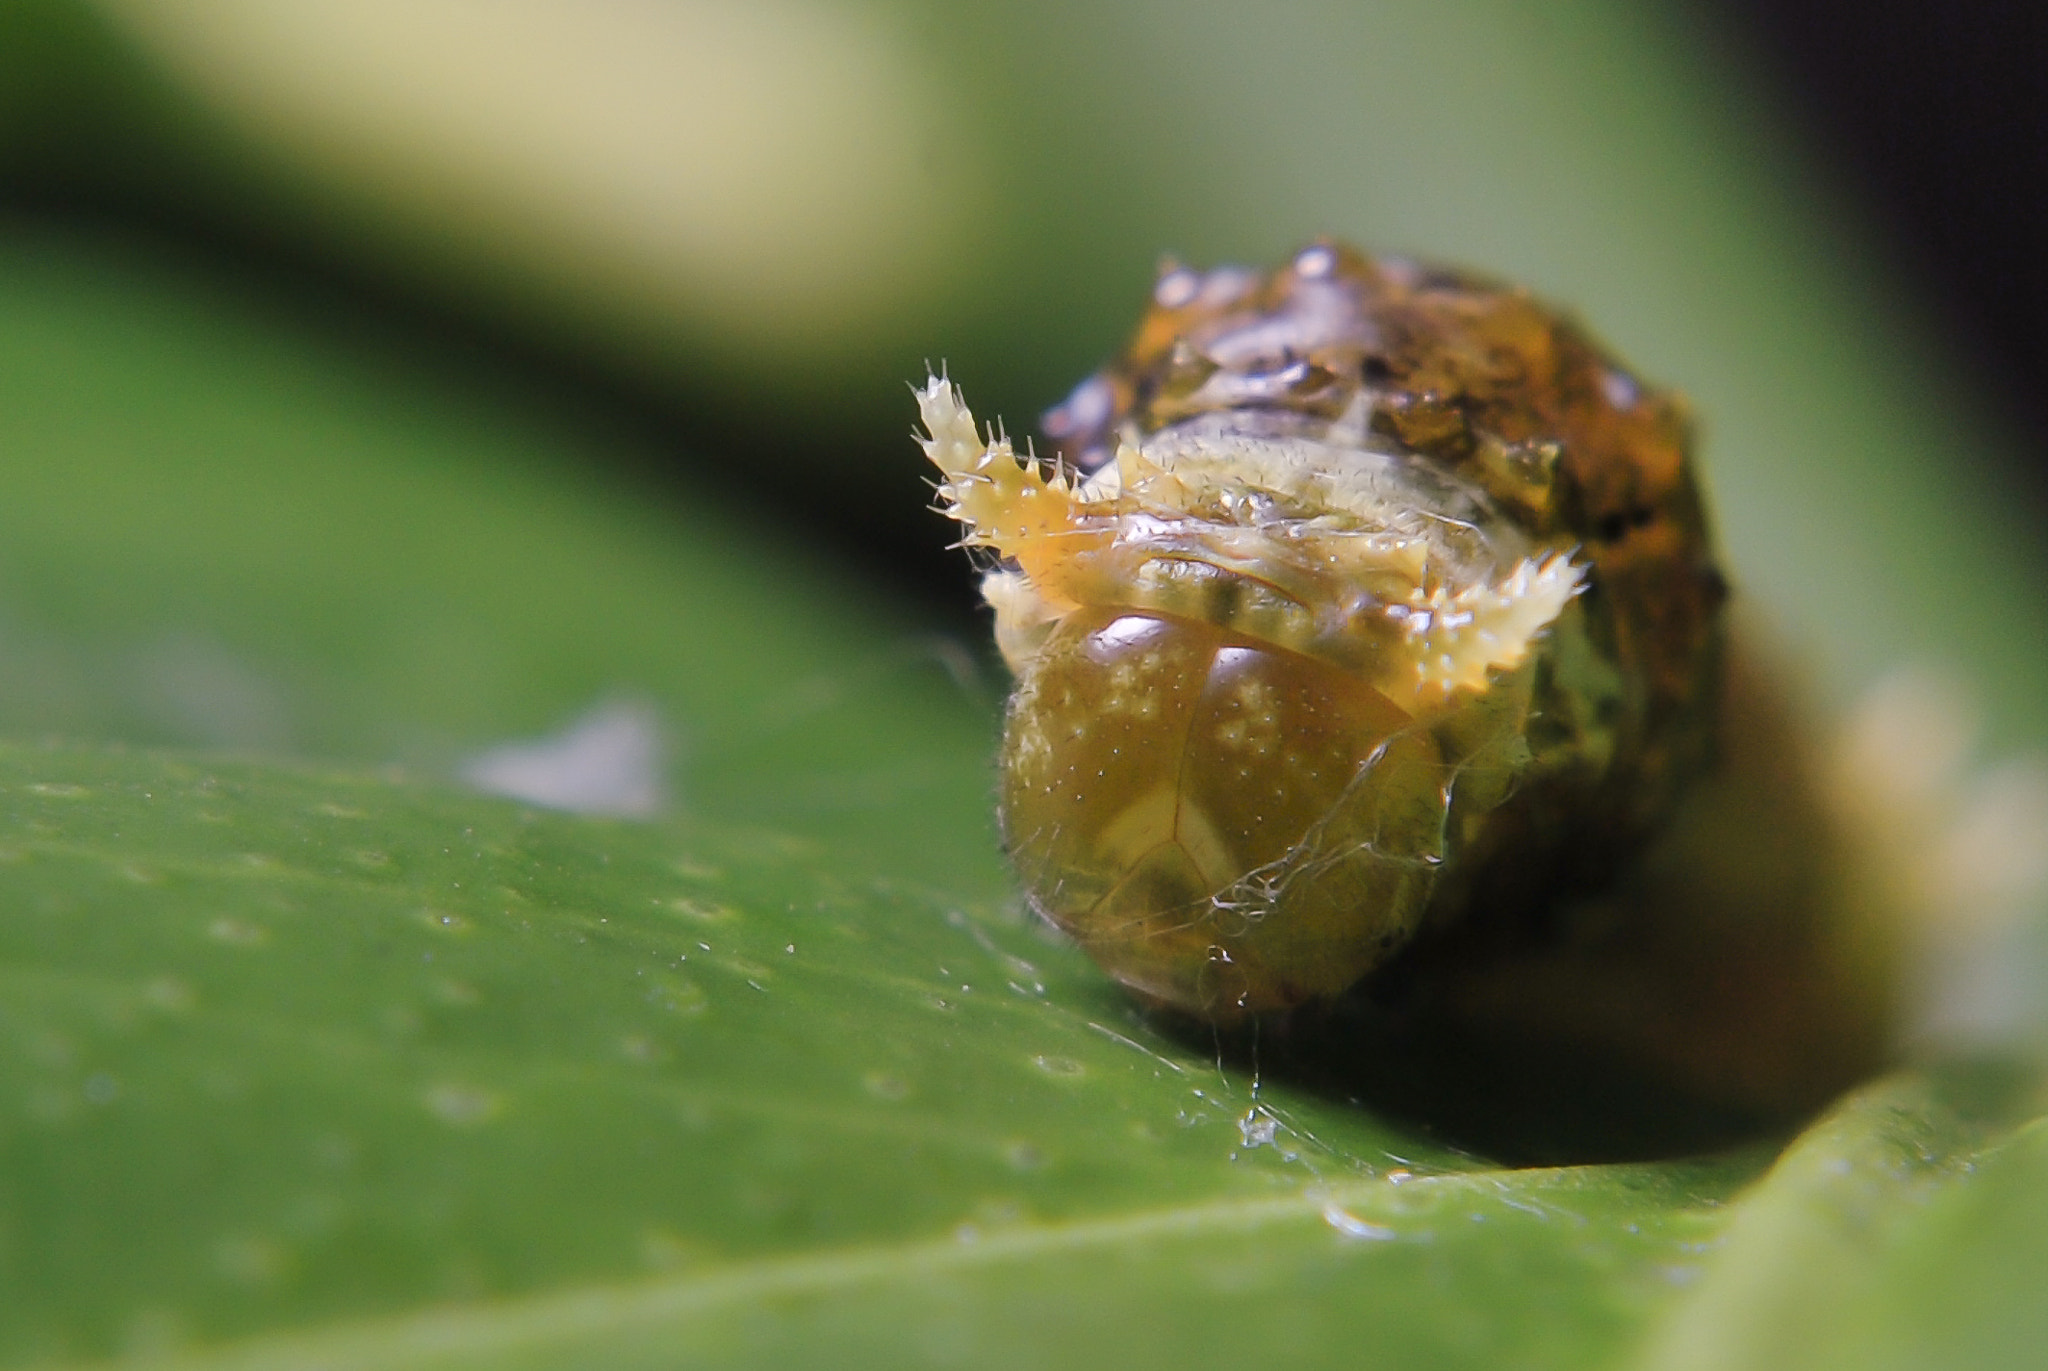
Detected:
left=0, top=224, right=1001, bottom=891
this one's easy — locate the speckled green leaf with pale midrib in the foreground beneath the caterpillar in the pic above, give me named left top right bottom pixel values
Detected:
left=0, top=748, right=1745, bottom=1367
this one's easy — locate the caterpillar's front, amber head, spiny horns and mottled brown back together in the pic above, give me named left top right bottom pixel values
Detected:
left=918, top=244, right=1724, bottom=1021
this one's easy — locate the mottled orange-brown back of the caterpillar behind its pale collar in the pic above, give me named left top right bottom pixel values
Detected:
left=1044, top=242, right=1726, bottom=914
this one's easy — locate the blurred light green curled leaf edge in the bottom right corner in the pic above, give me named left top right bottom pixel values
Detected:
left=1647, top=1070, right=2048, bottom=1371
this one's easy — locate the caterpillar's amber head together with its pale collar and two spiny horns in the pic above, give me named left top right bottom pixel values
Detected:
left=920, top=381, right=1581, bottom=1021
